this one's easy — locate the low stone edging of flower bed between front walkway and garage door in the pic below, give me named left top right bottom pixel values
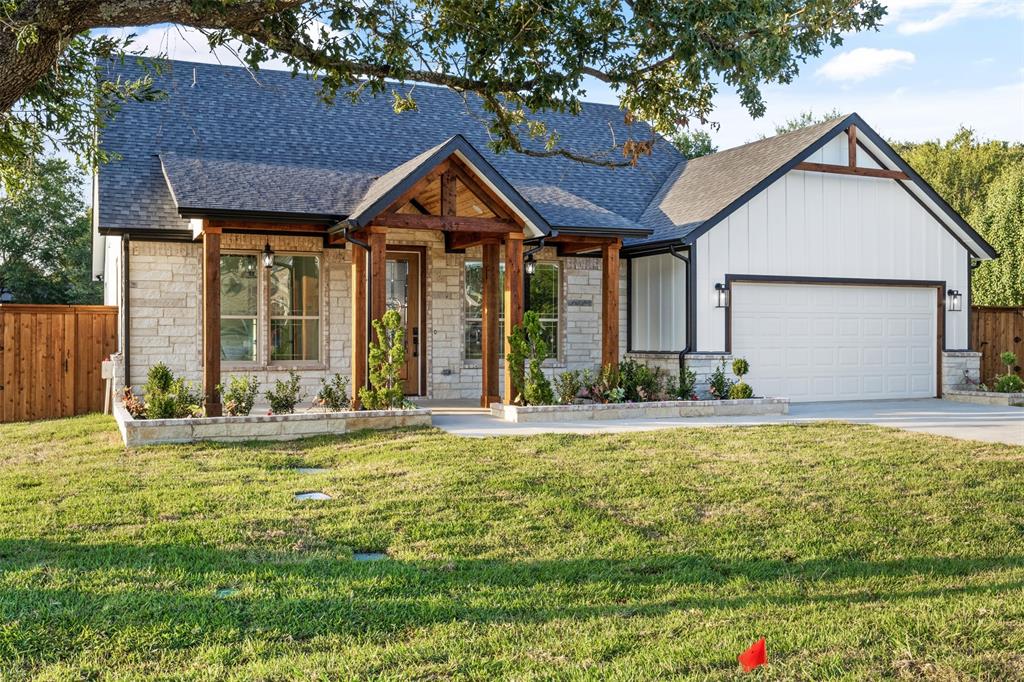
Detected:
left=490, top=397, right=790, bottom=423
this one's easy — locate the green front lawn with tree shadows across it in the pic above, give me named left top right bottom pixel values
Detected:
left=0, top=417, right=1024, bottom=680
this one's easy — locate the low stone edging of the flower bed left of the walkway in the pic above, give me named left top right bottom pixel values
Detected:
left=114, top=400, right=431, bottom=447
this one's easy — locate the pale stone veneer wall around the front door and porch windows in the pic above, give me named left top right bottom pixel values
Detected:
left=130, top=229, right=622, bottom=399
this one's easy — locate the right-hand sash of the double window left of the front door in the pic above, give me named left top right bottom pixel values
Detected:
left=270, top=256, right=319, bottom=361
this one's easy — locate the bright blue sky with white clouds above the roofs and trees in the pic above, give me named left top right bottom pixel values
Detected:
left=105, top=0, right=1024, bottom=148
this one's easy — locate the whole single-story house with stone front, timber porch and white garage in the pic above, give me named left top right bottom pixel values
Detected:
left=94, top=61, right=996, bottom=412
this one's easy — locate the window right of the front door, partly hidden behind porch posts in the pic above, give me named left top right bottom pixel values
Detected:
left=464, top=260, right=560, bottom=359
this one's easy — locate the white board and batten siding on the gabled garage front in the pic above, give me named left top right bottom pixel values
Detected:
left=695, top=150, right=968, bottom=351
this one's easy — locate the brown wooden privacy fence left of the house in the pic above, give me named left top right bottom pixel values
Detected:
left=0, top=303, right=118, bottom=422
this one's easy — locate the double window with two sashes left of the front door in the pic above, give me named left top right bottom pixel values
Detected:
left=220, top=254, right=321, bottom=364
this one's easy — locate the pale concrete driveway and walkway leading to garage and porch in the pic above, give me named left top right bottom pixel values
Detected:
left=433, top=398, right=1024, bottom=445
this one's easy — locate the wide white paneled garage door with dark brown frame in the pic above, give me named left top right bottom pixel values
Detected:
left=730, top=283, right=938, bottom=401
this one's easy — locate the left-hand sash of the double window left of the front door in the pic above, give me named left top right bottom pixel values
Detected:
left=220, top=255, right=259, bottom=363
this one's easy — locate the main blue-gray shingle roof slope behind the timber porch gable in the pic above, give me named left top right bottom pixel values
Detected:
left=98, top=61, right=682, bottom=238
